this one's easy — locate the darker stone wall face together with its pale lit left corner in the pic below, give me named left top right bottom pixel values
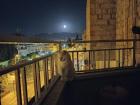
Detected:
left=85, top=0, right=116, bottom=48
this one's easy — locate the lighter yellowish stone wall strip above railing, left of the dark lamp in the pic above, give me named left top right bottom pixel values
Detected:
left=116, top=0, right=135, bottom=39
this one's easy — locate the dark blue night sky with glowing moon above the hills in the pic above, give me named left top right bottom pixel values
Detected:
left=0, top=0, right=86, bottom=35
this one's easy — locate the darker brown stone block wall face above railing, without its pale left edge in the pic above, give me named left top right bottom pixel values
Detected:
left=91, top=0, right=116, bottom=40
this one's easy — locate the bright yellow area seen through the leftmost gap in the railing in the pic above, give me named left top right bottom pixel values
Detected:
left=0, top=72, right=17, bottom=105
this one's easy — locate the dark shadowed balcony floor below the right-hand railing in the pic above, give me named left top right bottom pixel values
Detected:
left=57, top=71, right=140, bottom=105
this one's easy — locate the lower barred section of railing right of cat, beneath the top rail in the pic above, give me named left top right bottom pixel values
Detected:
left=69, top=48, right=133, bottom=72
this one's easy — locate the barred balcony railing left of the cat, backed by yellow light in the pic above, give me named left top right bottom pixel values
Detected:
left=0, top=55, right=58, bottom=105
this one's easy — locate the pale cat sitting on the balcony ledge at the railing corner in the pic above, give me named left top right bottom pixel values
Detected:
left=56, top=51, right=75, bottom=81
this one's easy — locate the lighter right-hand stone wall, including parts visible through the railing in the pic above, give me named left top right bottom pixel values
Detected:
left=116, top=0, right=140, bottom=63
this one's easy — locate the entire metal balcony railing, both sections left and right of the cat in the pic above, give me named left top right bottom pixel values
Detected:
left=0, top=40, right=138, bottom=105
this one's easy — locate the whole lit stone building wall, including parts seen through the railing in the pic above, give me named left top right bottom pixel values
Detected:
left=85, top=0, right=140, bottom=64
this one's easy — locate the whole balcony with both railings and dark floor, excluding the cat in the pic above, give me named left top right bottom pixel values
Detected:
left=0, top=39, right=140, bottom=105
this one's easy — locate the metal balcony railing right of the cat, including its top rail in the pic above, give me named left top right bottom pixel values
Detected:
left=66, top=39, right=139, bottom=72
